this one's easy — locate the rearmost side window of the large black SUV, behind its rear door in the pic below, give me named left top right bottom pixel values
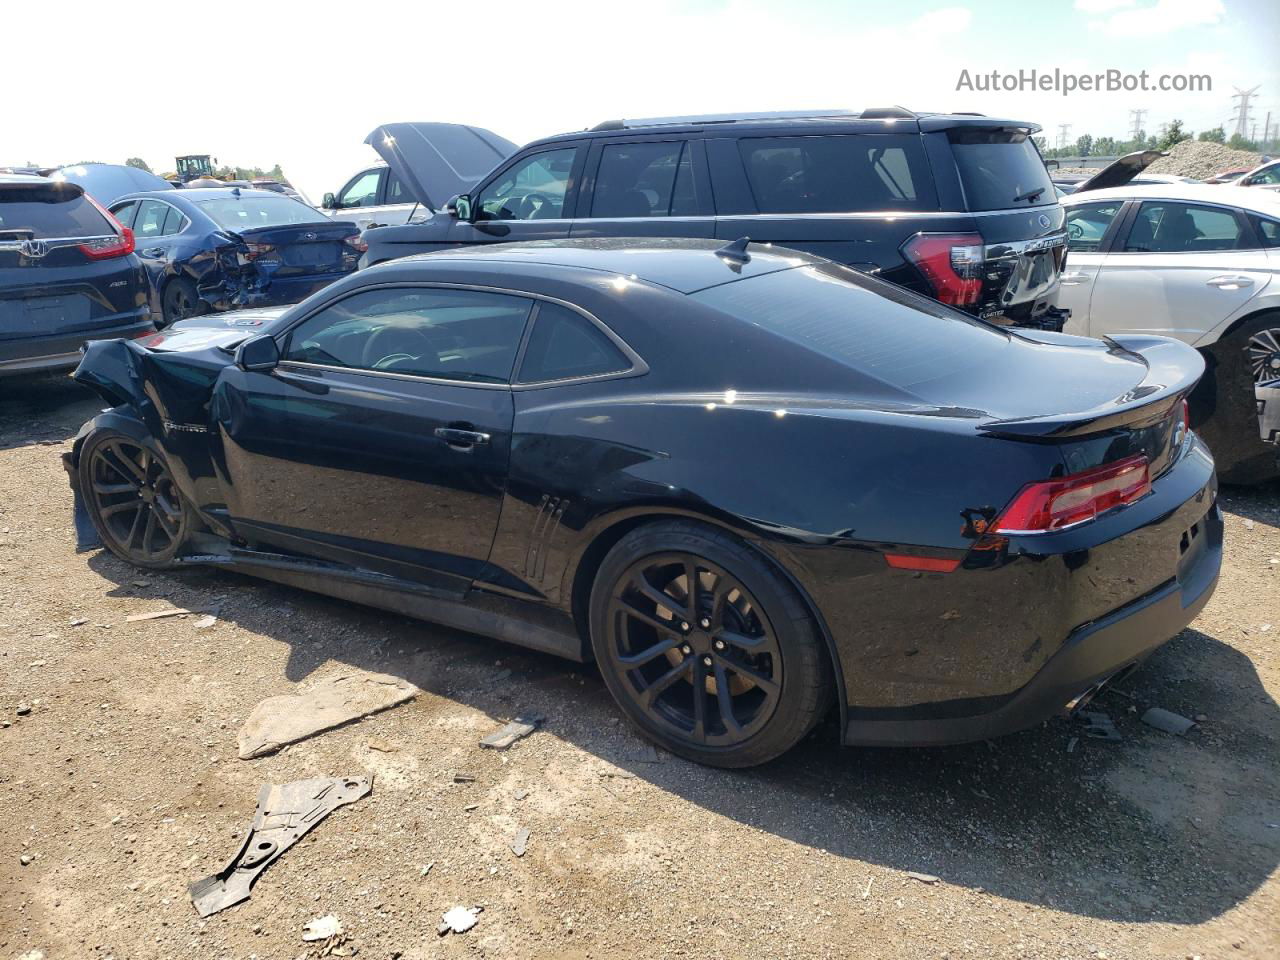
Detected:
left=739, top=133, right=938, bottom=214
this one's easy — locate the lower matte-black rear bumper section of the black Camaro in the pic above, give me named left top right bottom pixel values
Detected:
left=844, top=491, right=1222, bottom=746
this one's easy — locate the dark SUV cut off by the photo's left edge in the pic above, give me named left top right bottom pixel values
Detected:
left=0, top=174, right=156, bottom=378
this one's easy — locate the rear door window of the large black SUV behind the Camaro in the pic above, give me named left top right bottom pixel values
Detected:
left=591, top=141, right=692, bottom=218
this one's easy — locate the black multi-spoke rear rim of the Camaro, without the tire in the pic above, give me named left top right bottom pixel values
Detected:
left=608, top=553, right=782, bottom=748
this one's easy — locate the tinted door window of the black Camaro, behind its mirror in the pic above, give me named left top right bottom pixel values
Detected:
left=284, top=287, right=531, bottom=383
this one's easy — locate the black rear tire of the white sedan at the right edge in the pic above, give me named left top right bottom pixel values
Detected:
left=1189, top=311, right=1280, bottom=485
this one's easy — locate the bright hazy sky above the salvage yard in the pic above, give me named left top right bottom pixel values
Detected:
left=0, top=0, right=1280, bottom=201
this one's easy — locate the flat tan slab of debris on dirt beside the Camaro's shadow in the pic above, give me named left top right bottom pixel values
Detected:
left=237, top=671, right=420, bottom=760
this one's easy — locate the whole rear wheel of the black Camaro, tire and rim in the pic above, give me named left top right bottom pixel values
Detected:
left=590, top=521, right=832, bottom=767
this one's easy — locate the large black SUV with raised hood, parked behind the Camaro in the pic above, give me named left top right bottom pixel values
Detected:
left=362, top=108, right=1066, bottom=329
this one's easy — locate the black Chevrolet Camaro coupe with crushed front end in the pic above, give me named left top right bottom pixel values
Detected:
left=67, top=239, right=1222, bottom=767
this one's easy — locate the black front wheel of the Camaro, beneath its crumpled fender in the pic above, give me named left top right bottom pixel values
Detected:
left=79, top=430, right=191, bottom=570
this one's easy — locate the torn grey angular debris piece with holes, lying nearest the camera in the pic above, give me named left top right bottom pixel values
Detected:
left=187, top=777, right=372, bottom=916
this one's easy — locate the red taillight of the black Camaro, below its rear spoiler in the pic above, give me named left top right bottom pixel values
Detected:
left=991, top=454, right=1151, bottom=534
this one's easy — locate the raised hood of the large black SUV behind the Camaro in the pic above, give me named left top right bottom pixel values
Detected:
left=365, top=123, right=518, bottom=210
